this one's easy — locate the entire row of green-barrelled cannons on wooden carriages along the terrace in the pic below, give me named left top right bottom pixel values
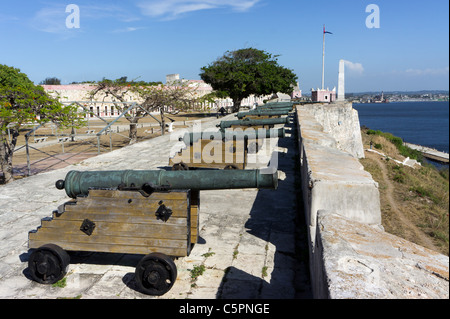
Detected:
left=28, top=103, right=293, bottom=296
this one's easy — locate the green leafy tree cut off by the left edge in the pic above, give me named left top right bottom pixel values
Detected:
left=0, top=64, right=83, bottom=183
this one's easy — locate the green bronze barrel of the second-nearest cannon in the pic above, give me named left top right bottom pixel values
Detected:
left=179, top=127, right=286, bottom=145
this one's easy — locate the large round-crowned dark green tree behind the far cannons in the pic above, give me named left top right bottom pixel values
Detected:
left=200, top=48, right=297, bottom=112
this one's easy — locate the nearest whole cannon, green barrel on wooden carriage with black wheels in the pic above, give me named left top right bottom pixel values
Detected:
left=28, top=170, right=278, bottom=296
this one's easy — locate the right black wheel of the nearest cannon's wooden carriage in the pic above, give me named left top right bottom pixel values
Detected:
left=135, top=253, right=177, bottom=296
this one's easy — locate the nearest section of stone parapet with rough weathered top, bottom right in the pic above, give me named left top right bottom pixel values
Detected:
left=314, top=211, right=449, bottom=299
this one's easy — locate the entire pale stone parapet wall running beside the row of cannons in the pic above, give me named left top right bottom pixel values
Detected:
left=297, top=103, right=449, bottom=299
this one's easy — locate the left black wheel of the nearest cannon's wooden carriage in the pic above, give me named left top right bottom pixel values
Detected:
left=28, top=244, right=70, bottom=284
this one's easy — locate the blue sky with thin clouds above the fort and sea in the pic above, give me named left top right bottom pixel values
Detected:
left=0, top=0, right=449, bottom=93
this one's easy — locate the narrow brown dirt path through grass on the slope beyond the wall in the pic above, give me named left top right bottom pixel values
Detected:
left=365, top=152, right=439, bottom=251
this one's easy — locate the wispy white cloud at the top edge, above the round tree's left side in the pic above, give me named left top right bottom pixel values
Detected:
left=138, top=0, right=260, bottom=19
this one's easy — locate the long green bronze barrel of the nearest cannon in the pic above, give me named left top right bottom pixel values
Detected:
left=56, top=169, right=278, bottom=198
